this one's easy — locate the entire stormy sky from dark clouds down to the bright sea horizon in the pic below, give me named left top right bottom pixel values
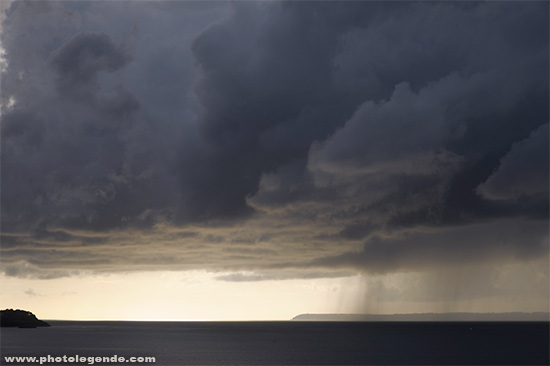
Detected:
left=0, top=0, right=550, bottom=320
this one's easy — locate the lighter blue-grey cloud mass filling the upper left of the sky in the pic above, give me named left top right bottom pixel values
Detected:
left=2, top=2, right=225, bottom=232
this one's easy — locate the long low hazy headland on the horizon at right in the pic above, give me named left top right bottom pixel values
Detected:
left=292, top=312, right=550, bottom=322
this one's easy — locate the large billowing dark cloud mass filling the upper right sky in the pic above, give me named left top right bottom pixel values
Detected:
left=245, top=3, right=548, bottom=271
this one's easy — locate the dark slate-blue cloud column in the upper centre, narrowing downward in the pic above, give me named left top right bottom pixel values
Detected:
left=182, top=3, right=366, bottom=219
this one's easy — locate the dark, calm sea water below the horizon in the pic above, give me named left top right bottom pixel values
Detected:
left=0, top=321, right=550, bottom=366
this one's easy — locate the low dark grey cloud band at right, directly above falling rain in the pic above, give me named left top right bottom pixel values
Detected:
left=316, top=220, right=549, bottom=273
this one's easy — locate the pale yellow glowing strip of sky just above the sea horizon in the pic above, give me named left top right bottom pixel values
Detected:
left=0, top=254, right=548, bottom=321
